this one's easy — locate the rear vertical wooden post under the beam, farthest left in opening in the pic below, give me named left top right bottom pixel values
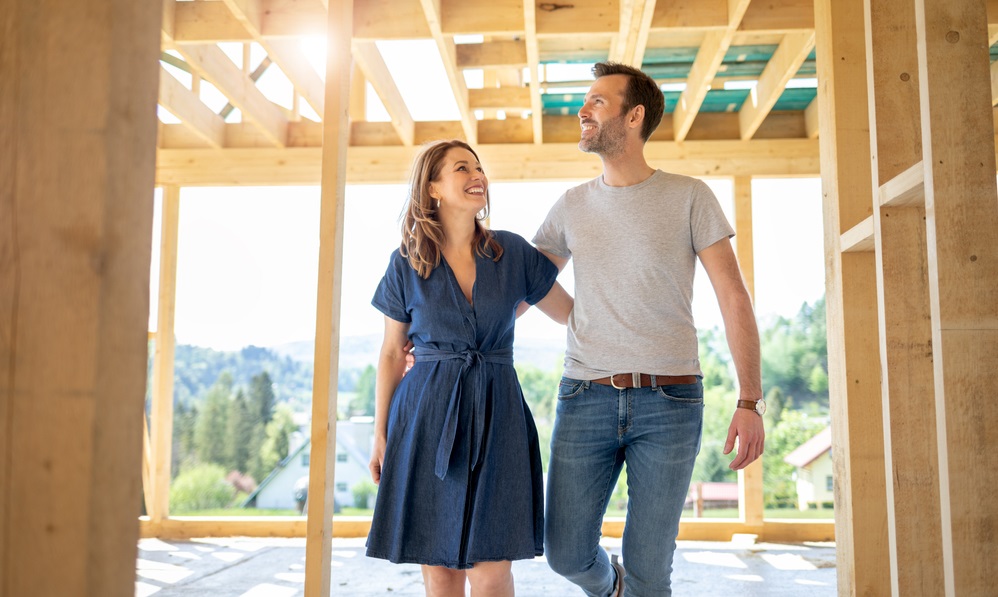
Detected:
left=148, top=185, right=180, bottom=525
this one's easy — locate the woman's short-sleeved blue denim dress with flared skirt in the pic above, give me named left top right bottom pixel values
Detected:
left=367, top=231, right=558, bottom=569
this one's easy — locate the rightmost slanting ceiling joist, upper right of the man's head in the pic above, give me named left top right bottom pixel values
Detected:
left=738, top=31, right=814, bottom=139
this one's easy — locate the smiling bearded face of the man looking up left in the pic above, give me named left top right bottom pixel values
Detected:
left=579, top=75, right=627, bottom=156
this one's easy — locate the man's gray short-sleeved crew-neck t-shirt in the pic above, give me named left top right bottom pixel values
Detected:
left=533, top=170, right=734, bottom=379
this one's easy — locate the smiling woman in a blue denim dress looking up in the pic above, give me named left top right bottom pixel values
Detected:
left=367, top=141, right=572, bottom=597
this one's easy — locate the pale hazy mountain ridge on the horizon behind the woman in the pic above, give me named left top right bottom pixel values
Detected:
left=270, top=334, right=565, bottom=371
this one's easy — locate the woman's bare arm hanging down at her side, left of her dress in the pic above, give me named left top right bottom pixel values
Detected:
left=368, top=316, right=409, bottom=483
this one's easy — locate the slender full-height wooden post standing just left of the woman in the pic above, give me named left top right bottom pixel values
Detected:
left=305, top=0, right=353, bottom=597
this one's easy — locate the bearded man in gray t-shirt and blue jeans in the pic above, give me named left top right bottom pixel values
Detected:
left=534, top=63, right=765, bottom=597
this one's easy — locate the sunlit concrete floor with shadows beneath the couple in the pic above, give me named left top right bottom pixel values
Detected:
left=135, top=537, right=837, bottom=597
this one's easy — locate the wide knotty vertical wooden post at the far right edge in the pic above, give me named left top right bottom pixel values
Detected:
left=912, top=0, right=998, bottom=596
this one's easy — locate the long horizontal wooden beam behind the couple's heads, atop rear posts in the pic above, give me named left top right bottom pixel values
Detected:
left=157, top=139, right=819, bottom=186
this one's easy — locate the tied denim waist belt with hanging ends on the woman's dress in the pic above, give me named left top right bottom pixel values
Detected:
left=415, top=346, right=513, bottom=479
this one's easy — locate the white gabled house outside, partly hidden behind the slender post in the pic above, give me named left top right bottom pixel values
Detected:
left=243, top=417, right=374, bottom=510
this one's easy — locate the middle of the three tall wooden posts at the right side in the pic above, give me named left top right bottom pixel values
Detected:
left=865, top=0, right=943, bottom=597
